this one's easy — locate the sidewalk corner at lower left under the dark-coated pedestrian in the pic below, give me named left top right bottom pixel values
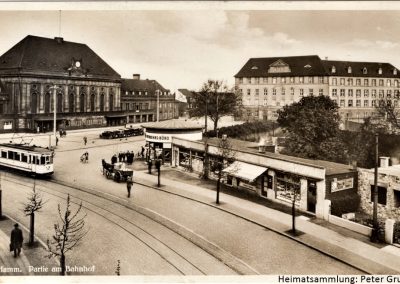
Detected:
left=0, top=216, right=58, bottom=276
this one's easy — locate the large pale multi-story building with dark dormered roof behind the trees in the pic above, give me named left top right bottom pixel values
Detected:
left=235, top=55, right=400, bottom=121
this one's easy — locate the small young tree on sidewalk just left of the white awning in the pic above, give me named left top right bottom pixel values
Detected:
left=212, top=135, right=237, bottom=204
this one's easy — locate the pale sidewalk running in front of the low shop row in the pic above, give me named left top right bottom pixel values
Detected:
left=134, top=168, right=400, bottom=274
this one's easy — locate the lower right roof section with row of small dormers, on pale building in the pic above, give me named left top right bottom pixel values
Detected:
left=322, top=60, right=400, bottom=78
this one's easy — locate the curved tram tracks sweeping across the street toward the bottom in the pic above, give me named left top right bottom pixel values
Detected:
left=3, top=176, right=225, bottom=275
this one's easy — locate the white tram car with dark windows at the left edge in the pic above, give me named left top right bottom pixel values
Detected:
left=0, top=143, right=54, bottom=176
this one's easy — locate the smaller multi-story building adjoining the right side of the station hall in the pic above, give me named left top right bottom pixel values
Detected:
left=121, top=74, right=179, bottom=123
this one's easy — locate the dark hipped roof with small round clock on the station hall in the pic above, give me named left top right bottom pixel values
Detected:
left=0, top=35, right=121, bottom=80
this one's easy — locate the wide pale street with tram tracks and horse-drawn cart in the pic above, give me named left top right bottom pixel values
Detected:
left=2, top=130, right=361, bottom=275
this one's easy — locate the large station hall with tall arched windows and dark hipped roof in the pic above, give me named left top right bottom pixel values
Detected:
left=0, top=35, right=123, bottom=132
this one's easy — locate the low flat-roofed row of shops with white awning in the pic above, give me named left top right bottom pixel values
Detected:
left=172, top=137, right=358, bottom=219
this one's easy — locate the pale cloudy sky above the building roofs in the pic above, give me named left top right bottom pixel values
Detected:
left=0, top=2, right=400, bottom=90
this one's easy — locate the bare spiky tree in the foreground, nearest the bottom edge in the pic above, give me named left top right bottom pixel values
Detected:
left=47, top=194, right=88, bottom=275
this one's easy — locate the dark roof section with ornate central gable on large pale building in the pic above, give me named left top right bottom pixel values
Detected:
left=235, top=55, right=327, bottom=77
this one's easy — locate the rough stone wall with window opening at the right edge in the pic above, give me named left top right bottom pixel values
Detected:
left=358, top=169, right=400, bottom=220
